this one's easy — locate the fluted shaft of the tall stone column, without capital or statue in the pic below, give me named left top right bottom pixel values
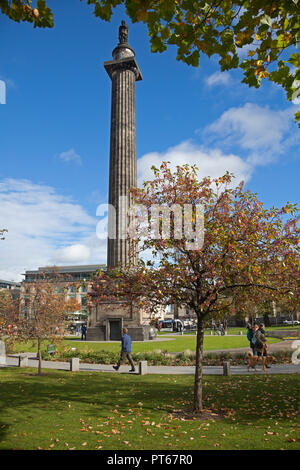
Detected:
left=107, top=67, right=137, bottom=268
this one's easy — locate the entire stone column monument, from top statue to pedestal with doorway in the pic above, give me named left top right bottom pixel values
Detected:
left=87, top=21, right=153, bottom=341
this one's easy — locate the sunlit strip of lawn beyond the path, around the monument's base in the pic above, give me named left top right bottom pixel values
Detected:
left=9, top=335, right=279, bottom=353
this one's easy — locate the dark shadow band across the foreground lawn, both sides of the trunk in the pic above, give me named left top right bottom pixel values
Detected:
left=0, top=368, right=299, bottom=444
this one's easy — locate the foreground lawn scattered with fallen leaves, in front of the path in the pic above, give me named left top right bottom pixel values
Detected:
left=0, top=368, right=300, bottom=451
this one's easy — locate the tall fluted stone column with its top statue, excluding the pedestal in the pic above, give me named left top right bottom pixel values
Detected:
left=104, top=21, right=142, bottom=270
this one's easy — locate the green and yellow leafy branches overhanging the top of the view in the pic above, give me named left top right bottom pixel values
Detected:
left=0, top=0, right=300, bottom=121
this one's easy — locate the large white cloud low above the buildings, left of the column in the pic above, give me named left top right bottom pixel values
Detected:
left=0, top=179, right=106, bottom=280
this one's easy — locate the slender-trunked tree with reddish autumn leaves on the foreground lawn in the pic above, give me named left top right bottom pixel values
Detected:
left=90, top=163, right=299, bottom=412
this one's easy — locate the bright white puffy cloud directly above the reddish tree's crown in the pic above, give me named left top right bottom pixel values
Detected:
left=138, top=141, right=252, bottom=185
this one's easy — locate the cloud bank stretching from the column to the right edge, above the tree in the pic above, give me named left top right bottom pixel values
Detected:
left=138, top=103, right=300, bottom=186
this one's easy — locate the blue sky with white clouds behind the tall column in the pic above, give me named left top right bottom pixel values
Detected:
left=0, top=0, right=300, bottom=280
